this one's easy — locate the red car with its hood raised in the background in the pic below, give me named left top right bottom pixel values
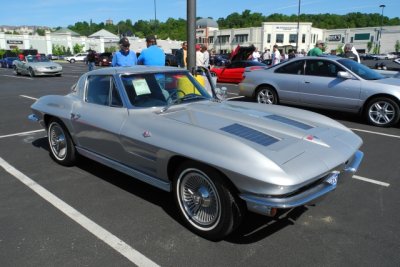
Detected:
left=211, top=46, right=267, bottom=83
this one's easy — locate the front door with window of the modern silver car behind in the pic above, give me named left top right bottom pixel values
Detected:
left=299, top=58, right=361, bottom=111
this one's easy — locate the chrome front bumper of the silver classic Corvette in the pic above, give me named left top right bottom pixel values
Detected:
left=240, top=151, right=364, bottom=215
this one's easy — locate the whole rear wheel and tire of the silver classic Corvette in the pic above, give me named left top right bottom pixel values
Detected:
left=47, top=119, right=76, bottom=166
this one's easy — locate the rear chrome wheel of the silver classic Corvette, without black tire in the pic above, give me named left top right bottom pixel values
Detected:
left=48, top=122, right=68, bottom=160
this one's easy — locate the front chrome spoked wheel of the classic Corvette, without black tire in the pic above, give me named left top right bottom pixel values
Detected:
left=177, top=169, right=221, bottom=230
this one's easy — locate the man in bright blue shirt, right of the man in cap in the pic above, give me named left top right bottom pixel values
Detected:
left=138, top=35, right=165, bottom=66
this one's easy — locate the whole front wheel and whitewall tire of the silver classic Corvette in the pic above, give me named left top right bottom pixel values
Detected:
left=173, top=161, right=245, bottom=241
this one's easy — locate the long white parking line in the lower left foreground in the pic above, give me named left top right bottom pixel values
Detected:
left=0, top=157, right=159, bottom=266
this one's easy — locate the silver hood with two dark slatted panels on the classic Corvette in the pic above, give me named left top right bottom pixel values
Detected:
left=160, top=101, right=362, bottom=176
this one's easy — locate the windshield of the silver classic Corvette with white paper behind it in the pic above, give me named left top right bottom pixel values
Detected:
left=121, top=71, right=211, bottom=107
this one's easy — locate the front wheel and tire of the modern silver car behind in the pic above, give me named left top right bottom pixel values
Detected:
left=365, top=97, right=400, bottom=127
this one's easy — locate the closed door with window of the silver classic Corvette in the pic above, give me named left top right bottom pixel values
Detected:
left=71, top=75, right=128, bottom=161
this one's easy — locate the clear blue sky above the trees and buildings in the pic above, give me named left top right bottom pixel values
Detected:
left=0, top=0, right=400, bottom=27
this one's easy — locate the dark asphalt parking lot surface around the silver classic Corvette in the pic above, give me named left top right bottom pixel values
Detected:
left=0, top=63, right=400, bottom=266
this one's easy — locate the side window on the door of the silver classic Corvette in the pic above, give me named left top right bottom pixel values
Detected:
left=86, top=75, right=122, bottom=107
